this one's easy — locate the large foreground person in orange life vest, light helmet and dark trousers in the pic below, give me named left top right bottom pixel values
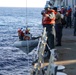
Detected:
left=41, top=4, right=55, bottom=58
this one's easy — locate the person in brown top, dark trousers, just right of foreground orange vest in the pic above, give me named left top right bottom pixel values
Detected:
left=53, top=7, right=63, bottom=46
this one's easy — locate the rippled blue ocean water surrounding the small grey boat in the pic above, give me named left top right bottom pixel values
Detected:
left=0, top=7, right=42, bottom=75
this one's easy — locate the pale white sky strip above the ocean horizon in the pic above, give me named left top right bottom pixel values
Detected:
left=0, top=0, right=46, bottom=7
